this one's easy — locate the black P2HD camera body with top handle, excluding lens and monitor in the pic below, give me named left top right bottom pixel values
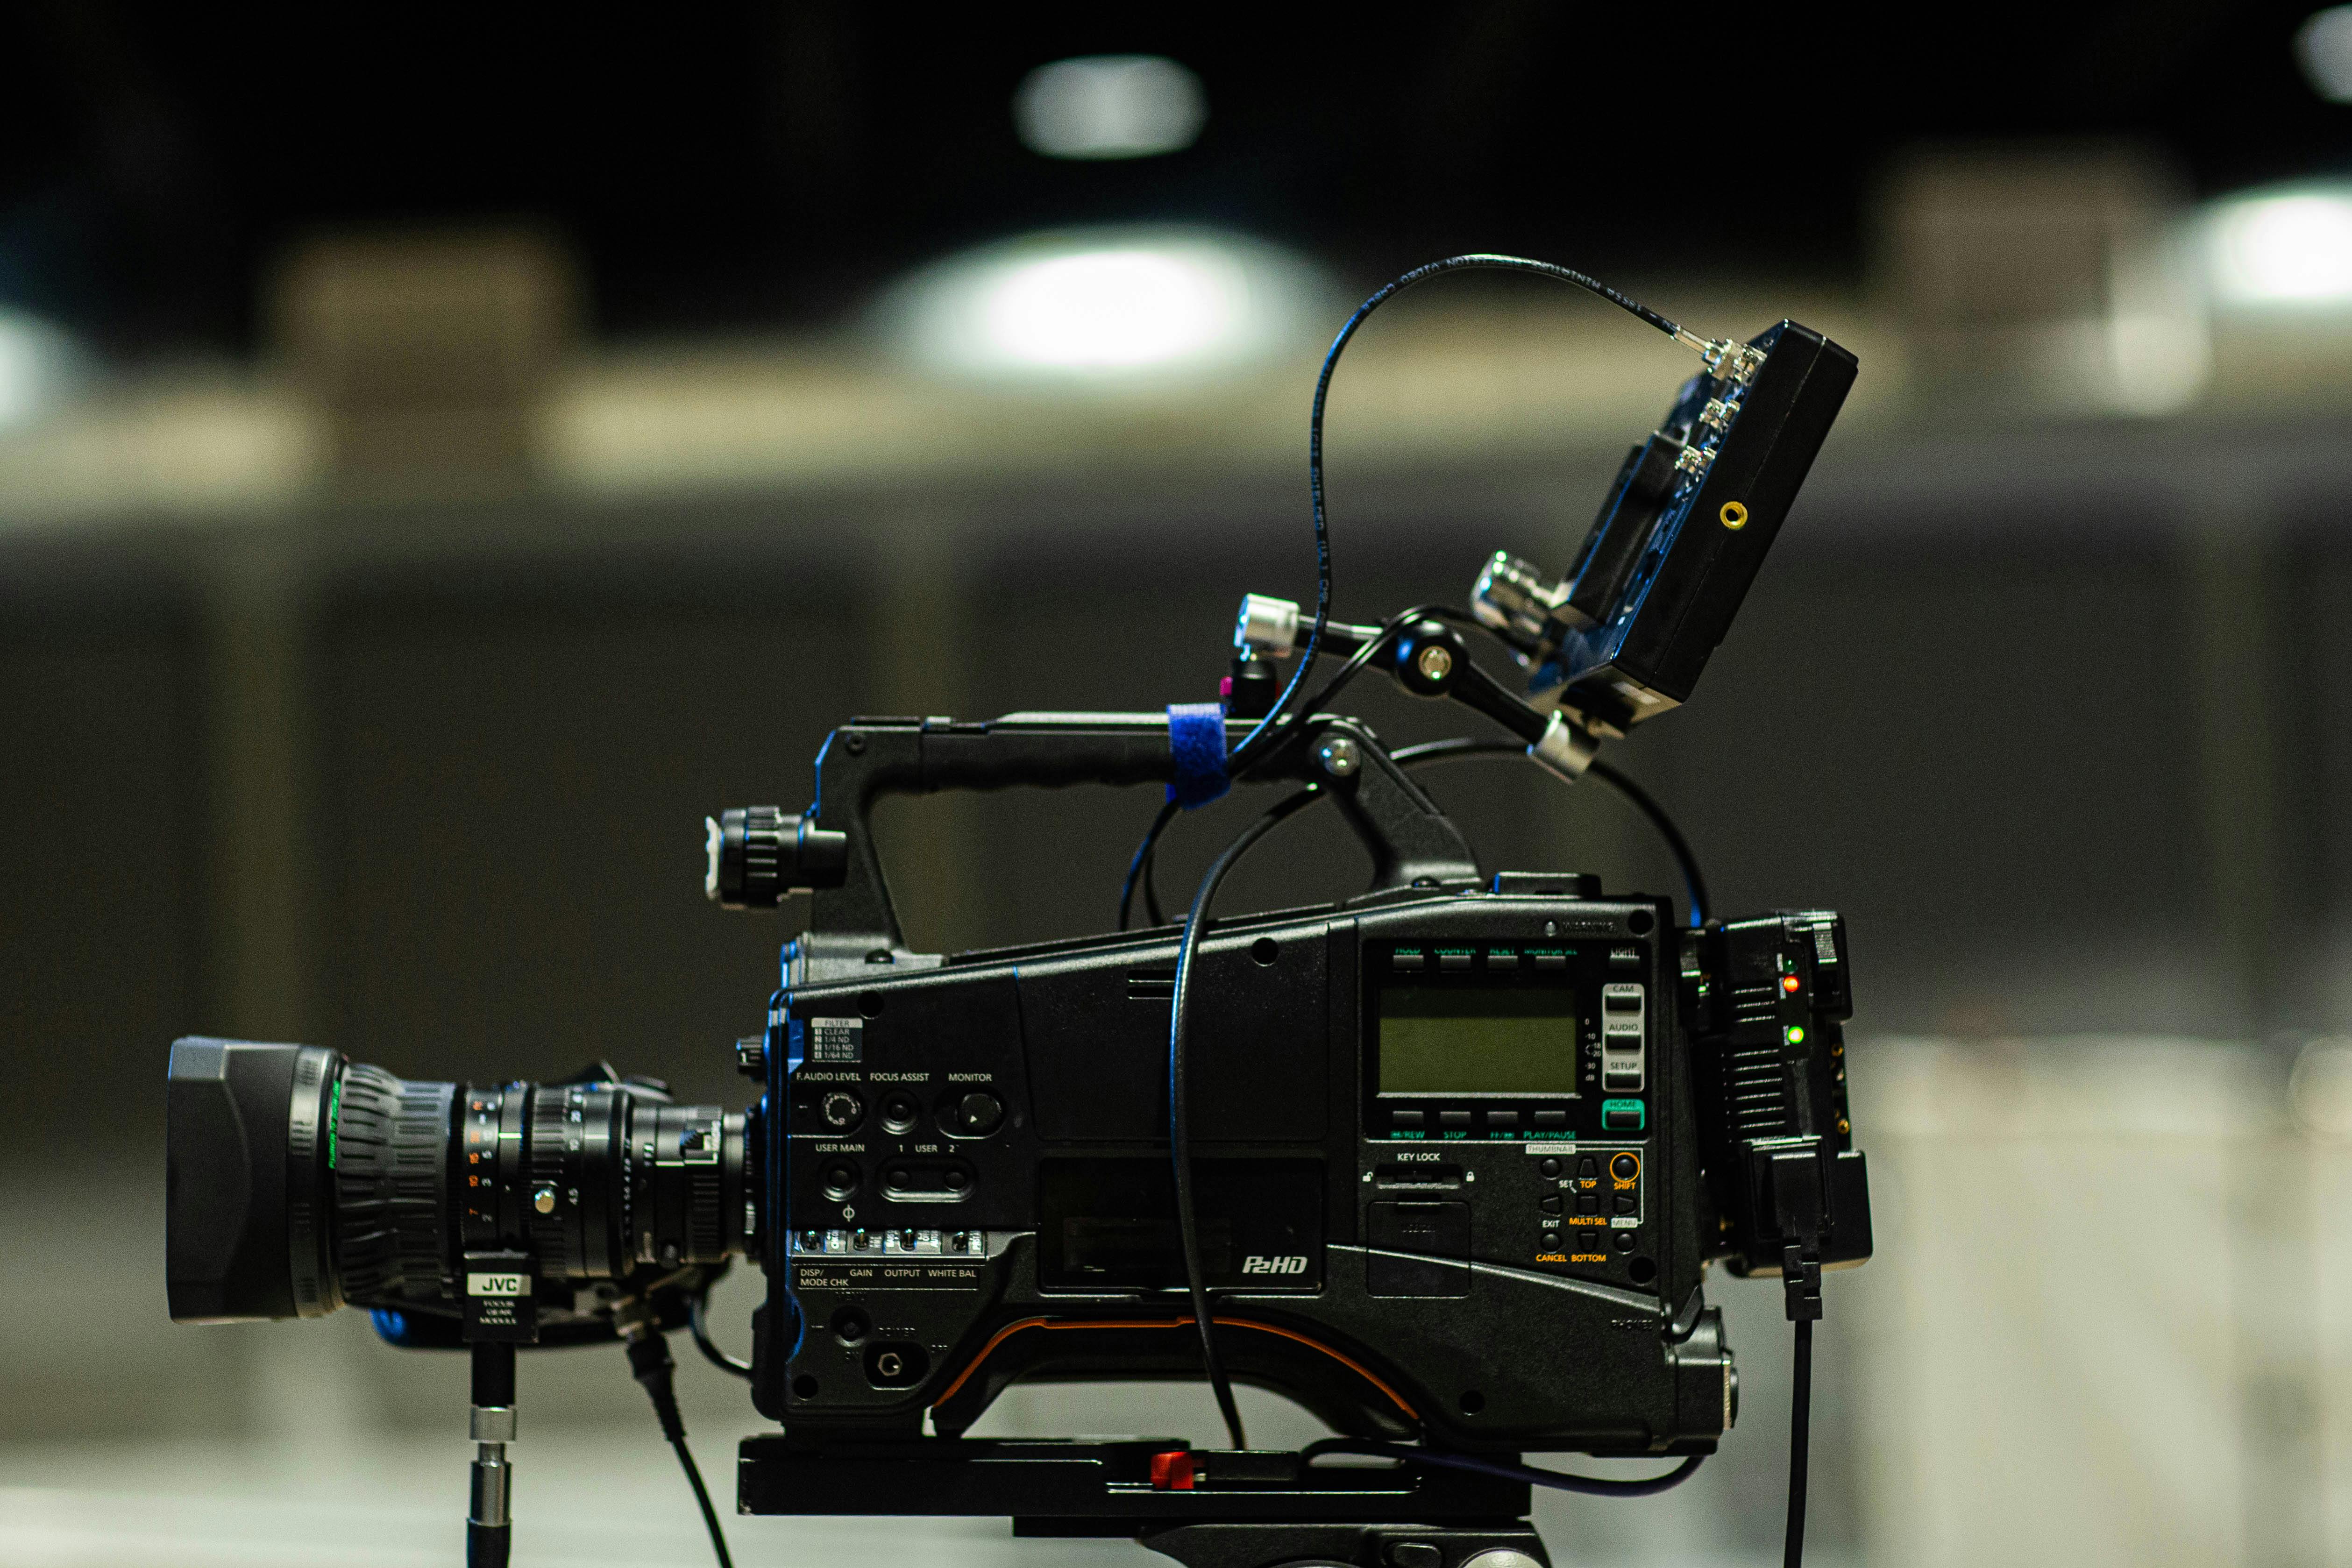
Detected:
left=738, top=715, right=1870, bottom=1455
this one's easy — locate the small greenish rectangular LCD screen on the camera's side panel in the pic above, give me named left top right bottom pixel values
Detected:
left=1381, top=985, right=1578, bottom=1095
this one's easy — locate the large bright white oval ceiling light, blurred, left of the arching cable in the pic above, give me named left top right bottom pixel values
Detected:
left=884, top=228, right=1322, bottom=383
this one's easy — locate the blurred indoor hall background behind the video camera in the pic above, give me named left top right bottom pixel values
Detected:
left=0, top=0, right=2352, bottom=1568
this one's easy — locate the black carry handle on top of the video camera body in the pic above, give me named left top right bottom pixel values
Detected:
left=743, top=712, right=1479, bottom=983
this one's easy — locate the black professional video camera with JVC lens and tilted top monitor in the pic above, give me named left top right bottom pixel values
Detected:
left=167, top=259, right=1870, bottom=1568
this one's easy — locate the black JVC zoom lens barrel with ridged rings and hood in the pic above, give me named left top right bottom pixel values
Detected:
left=164, top=1039, right=755, bottom=1324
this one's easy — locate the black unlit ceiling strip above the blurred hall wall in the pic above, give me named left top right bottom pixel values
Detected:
left=0, top=0, right=2352, bottom=355
